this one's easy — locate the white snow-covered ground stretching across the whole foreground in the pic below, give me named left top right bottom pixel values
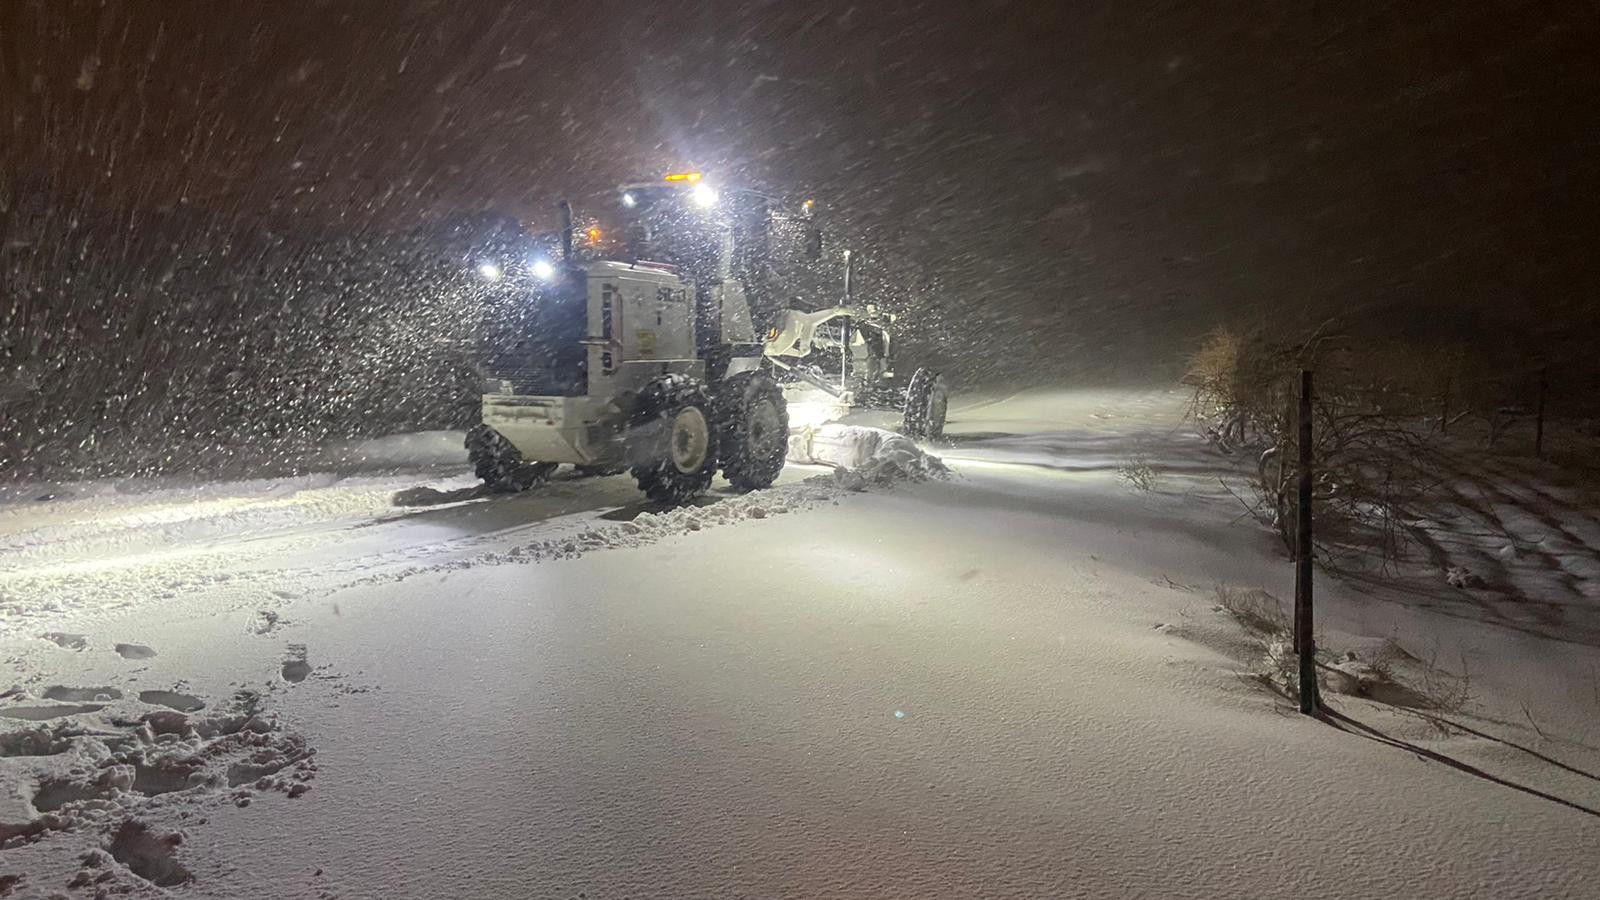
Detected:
left=0, top=391, right=1600, bottom=898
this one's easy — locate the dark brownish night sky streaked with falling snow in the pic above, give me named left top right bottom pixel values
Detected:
left=0, top=0, right=1600, bottom=375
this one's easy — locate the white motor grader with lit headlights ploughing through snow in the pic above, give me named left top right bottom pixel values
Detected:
left=466, top=173, right=946, bottom=503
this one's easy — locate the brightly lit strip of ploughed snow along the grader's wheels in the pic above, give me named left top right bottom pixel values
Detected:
left=0, top=426, right=944, bottom=639
